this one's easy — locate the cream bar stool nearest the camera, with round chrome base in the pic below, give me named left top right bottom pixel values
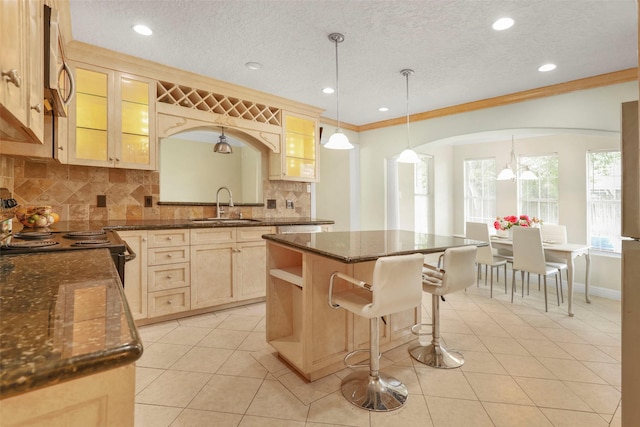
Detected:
left=329, top=254, right=424, bottom=411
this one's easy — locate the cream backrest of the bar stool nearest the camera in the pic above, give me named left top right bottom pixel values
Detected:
left=367, top=254, right=424, bottom=316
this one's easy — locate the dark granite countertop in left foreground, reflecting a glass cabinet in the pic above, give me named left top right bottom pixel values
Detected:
left=0, top=249, right=142, bottom=398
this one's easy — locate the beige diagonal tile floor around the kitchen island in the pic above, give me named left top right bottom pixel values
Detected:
left=135, top=285, right=621, bottom=427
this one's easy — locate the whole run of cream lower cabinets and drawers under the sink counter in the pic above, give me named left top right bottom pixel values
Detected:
left=118, top=227, right=275, bottom=323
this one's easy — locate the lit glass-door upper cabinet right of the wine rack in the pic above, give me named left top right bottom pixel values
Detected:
left=269, top=112, right=320, bottom=182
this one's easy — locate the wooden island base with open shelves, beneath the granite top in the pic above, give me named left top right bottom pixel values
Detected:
left=266, top=241, right=420, bottom=381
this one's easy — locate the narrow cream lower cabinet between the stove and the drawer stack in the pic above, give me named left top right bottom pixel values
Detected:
left=118, top=230, right=148, bottom=320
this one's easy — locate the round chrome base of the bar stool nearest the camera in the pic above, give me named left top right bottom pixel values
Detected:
left=341, top=371, right=409, bottom=411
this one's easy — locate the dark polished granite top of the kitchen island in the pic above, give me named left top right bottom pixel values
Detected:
left=263, top=230, right=487, bottom=264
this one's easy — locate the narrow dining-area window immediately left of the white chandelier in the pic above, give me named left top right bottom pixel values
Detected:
left=464, top=158, right=496, bottom=223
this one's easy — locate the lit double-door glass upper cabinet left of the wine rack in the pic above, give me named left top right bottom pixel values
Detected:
left=69, top=64, right=156, bottom=170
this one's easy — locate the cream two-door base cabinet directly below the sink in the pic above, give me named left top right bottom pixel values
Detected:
left=191, top=227, right=275, bottom=309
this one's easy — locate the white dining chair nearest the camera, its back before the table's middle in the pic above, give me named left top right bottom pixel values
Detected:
left=511, top=227, right=566, bottom=311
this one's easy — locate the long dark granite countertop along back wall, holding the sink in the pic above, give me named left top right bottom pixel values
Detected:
left=13, top=217, right=334, bottom=233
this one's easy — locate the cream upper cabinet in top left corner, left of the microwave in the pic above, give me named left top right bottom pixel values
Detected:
left=0, top=0, right=44, bottom=145
